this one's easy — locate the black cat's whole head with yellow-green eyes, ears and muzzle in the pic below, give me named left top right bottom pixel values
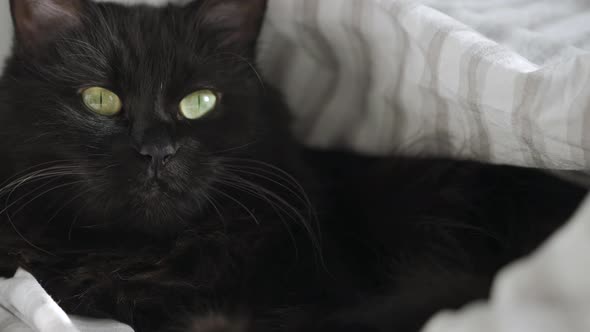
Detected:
left=0, top=0, right=294, bottom=235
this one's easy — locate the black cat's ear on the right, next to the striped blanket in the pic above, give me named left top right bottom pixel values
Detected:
left=197, top=0, right=267, bottom=52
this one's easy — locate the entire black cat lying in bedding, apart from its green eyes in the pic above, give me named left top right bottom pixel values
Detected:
left=0, top=0, right=585, bottom=332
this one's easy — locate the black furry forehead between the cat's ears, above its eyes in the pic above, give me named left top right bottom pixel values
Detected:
left=59, top=4, right=207, bottom=91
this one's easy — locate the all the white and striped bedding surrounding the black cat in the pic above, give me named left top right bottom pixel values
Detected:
left=0, top=0, right=590, bottom=332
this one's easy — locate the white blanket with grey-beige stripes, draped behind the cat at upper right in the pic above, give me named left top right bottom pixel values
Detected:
left=261, top=0, right=590, bottom=169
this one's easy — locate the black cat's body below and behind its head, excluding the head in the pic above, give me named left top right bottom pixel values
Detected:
left=0, top=152, right=584, bottom=331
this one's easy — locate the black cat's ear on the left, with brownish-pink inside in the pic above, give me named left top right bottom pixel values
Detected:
left=10, top=0, right=85, bottom=48
